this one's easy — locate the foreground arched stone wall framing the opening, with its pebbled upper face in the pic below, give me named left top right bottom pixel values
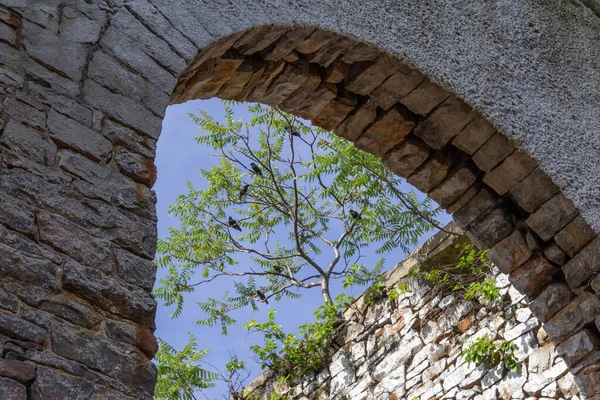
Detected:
left=0, top=0, right=600, bottom=399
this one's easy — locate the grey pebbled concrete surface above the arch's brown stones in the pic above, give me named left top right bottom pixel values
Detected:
left=150, top=0, right=600, bottom=232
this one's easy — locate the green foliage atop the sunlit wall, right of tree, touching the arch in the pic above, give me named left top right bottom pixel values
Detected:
left=408, top=243, right=501, bottom=303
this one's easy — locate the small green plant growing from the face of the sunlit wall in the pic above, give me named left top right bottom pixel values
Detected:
left=463, top=334, right=520, bottom=372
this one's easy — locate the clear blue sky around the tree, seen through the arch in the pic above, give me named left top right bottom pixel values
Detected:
left=154, top=99, right=450, bottom=400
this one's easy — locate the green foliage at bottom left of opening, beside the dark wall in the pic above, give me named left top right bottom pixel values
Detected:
left=154, top=334, right=217, bottom=400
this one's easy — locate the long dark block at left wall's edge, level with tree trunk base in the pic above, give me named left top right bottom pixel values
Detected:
left=63, top=260, right=156, bottom=327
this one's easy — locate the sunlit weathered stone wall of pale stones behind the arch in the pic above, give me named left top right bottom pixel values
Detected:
left=247, top=228, right=580, bottom=400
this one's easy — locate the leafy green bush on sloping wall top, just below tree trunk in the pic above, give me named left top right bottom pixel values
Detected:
left=244, top=294, right=352, bottom=383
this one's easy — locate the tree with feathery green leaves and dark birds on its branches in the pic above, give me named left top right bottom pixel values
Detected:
left=155, top=102, right=439, bottom=334
